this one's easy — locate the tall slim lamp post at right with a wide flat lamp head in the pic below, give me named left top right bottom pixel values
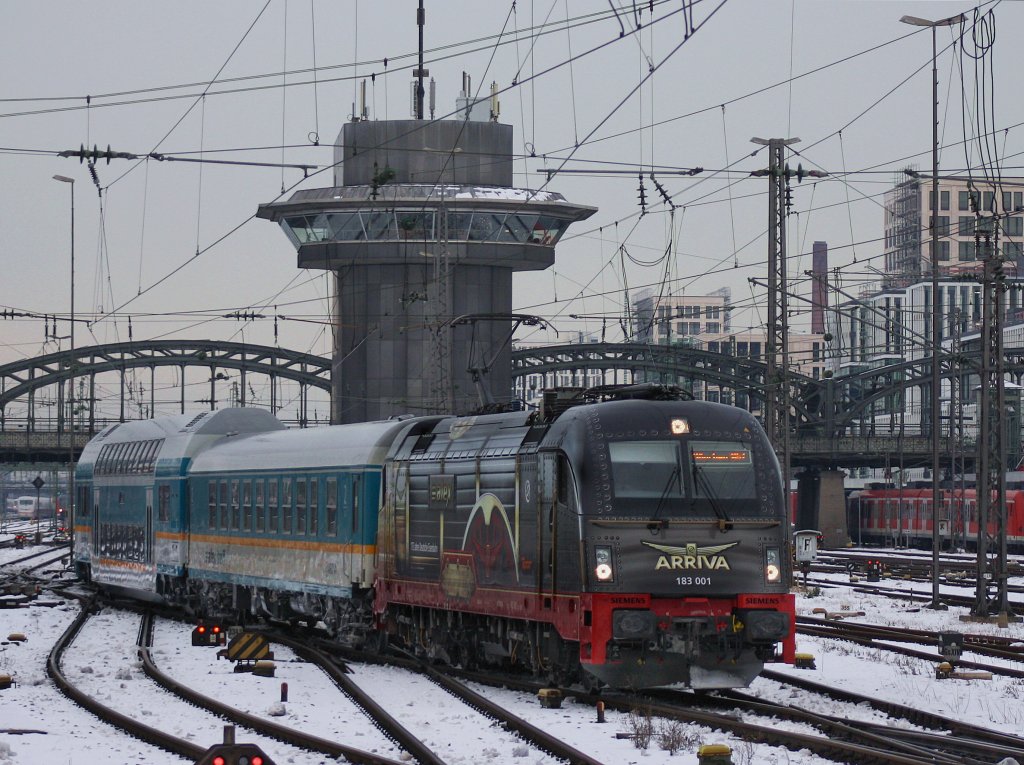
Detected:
left=900, top=13, right=966, bottom=608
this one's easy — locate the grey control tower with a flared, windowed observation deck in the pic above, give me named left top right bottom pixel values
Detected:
left=257, top=88, right=596, bottom=423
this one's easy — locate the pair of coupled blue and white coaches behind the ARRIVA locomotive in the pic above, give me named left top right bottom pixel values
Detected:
left=75, top=409, right=436, bottom=626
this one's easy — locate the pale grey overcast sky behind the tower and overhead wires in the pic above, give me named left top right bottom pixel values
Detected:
left=0, top=0, right=1024, bottom=415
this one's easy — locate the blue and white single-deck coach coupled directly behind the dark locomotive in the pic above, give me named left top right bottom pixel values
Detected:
left=188, top=420, right=419, bottom=625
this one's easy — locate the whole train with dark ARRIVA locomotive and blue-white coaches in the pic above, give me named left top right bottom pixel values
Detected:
left=75, top=391, right=795, bottom=688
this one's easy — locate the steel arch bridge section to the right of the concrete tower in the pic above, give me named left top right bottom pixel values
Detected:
left=512, top=343, right=1024, bottom=467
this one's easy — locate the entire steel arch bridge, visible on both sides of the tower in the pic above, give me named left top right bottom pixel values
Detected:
left=6, top=340, right=1024, bottom=467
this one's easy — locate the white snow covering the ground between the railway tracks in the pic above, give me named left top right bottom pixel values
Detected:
left=0, top=550, right=1024, bottom=765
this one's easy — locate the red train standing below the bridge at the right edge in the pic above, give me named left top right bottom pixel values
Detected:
left=847, top=486, right=1024, bottom=550
